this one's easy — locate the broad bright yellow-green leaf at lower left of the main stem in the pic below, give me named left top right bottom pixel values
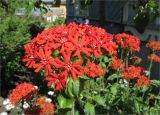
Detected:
left=57, top=94, right=74, bottom=109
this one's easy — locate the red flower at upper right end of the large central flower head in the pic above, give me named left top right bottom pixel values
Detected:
left=88, top=28, right=117, bottom=58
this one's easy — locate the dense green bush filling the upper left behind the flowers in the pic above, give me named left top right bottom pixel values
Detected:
left=0, top=0, right=64, bottom=95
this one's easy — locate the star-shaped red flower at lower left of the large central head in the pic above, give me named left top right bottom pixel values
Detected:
left=34, top=47, right=54, bottom=75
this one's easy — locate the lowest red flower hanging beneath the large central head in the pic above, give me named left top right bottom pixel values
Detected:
left=46, top=71, right=67, bottom=91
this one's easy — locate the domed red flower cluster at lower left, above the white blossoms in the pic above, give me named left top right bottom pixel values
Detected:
left=9, top=83, right=38, bottom=105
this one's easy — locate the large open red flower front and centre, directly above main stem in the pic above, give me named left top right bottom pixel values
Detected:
left=53, top=51, right=83, bottom=80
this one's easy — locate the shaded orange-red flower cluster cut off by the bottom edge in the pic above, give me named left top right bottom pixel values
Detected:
left=25, top=97, right=54, bottom=115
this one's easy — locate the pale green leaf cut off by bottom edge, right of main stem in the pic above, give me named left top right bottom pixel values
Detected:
left=85, top=103, right=95, bottom=115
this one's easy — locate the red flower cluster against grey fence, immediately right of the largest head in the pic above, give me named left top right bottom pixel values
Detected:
left=115, top=33, right=140, bottom=51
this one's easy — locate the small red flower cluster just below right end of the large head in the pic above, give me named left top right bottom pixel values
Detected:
left=110, top=57, right=125, bottom=70
